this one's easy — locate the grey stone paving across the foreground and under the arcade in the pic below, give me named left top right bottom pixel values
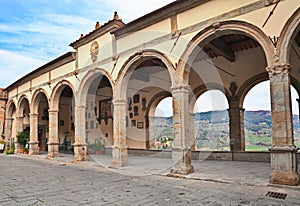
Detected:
left=0, top=154, right=300, bottom=206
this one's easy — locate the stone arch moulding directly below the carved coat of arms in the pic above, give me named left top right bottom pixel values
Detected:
left=75, top=68, right=115, bottom=106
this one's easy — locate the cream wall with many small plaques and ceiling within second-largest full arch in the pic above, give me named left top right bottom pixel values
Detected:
left=126, top=57, right=171, bottom=149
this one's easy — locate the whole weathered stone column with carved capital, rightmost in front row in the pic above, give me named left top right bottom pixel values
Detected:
left=267, top=64, right=299, bottom=185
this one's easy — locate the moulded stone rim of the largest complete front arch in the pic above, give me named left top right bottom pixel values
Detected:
left=176, top=20, right=275, bottom=84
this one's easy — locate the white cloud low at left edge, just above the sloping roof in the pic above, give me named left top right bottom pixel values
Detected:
left=0, top=50, right=44, bottom=88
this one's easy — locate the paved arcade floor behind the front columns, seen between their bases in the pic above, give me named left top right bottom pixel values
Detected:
left=9, top=154, right=300, bottom=187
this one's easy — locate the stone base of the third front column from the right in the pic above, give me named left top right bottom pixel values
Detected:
left=111, top=147, right=128, bottom=168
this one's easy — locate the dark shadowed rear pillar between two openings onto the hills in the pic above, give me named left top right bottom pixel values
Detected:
left=228, top=96, right=245, bottom=151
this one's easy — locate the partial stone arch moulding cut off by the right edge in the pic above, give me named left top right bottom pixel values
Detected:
left=276, top=8, right=300, bottom=63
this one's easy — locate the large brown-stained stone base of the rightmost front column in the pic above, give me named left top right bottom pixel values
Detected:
left=269, top=146, right=300, bottom=186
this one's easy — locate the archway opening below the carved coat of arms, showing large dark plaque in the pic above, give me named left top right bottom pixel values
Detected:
left=85, top=74, right=113, bottom=154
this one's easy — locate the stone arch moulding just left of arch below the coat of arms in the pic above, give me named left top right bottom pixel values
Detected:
left=49, top=80, right=75, bottom=110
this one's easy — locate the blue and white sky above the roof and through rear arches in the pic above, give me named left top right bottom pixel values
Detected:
left=0, top=0, right=299, bottom=116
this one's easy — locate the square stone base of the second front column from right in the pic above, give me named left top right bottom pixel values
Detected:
left=170, top=148, right=194, bottom=175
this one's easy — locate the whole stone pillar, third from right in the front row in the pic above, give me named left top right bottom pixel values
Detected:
left=112, top=99, right=128, bottom=168
